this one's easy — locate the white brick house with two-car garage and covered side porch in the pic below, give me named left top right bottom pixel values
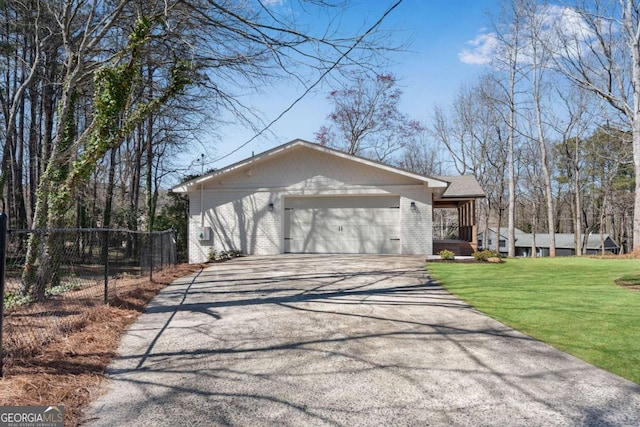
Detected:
left=172, top=140, right=484, bottom=263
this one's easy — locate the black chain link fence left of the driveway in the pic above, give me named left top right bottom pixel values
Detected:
left=0, top=224, right=176, bottom=372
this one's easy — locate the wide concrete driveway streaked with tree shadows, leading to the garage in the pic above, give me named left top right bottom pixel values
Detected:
left=87, top=255, right=640, bottom=426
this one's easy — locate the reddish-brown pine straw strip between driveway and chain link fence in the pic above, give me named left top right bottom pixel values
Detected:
left=0, top=264, right=204, bottom=426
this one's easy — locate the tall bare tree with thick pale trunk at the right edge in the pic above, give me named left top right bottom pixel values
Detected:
left=550, top=0, right=640, bottom=249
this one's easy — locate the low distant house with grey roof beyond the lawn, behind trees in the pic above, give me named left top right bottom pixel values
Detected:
left=478, top=227, right=620, bottom=257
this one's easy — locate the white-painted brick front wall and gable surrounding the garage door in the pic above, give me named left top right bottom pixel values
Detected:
left=189, top=147, right=433, bottom=263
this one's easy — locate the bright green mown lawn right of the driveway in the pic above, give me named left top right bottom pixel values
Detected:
left=427, top=257, right=640, bottom=384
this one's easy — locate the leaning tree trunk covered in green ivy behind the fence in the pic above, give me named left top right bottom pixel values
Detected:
left=23, top=17, right=190, bottom=299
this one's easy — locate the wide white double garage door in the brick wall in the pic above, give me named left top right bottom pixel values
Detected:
left=284, top=196, right=400, bottom=254
